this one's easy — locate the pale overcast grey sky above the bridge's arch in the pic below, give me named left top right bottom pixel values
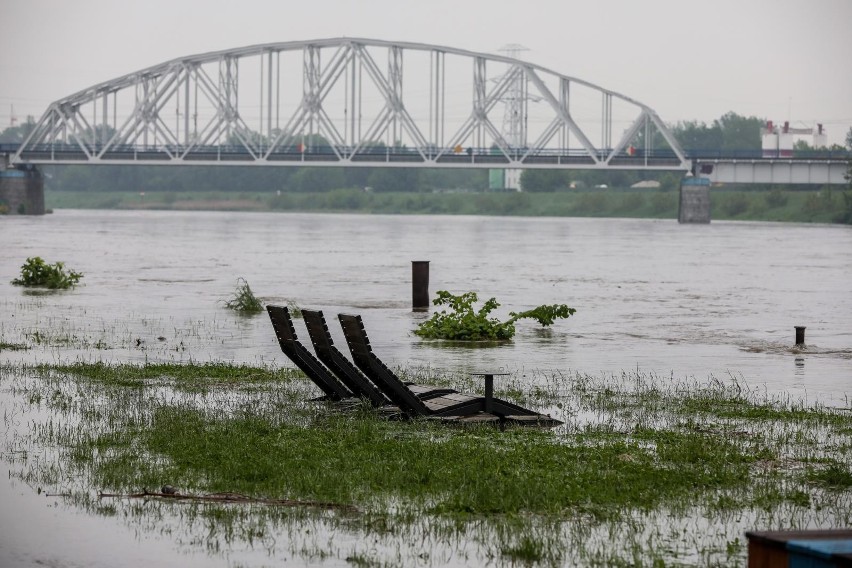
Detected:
left=5, top=0, right=852, bottom=143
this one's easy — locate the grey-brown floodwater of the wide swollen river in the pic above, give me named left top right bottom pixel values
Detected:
left=0, top=211, right=852, bottom=566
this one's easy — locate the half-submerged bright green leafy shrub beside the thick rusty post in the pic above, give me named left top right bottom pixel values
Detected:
left=414, top=290, right=577, bottom=341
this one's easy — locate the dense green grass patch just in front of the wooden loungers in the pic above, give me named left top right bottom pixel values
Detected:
left=116, top=408, right=754, bottom=518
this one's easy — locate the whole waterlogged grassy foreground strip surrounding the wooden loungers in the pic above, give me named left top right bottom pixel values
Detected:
left=3, top=363, right=852, bottom=566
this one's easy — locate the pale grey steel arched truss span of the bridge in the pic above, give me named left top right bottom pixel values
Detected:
left=11, top=38, right=691, bottom=171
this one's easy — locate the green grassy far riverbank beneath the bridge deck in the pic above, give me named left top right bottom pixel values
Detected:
left=45, top=188, right=852, bottom=223
